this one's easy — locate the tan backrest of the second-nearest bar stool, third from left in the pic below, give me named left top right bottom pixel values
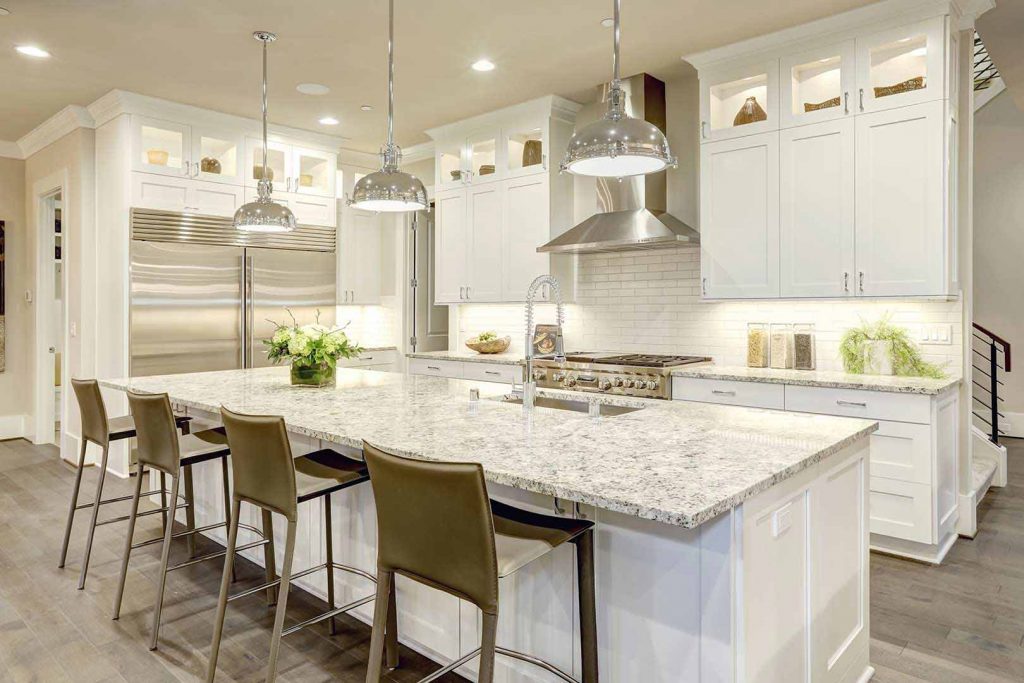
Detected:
left=220, top=408, right=298, bottom=521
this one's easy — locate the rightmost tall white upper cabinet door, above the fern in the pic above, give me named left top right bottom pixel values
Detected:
left=856, top=100, right=946, bottom=296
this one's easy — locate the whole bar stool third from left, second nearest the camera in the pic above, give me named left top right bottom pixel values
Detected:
left=206, top=408, right=397, bottom=683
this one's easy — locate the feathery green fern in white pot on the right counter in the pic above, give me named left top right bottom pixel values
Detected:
left=839, top=314, right=945, bottom=378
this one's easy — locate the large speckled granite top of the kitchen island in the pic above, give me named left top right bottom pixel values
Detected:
left=101, top=368, right=878, bottom=527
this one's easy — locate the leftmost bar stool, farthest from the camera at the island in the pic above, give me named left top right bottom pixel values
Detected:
left=57, top=379, right=190, bottom=591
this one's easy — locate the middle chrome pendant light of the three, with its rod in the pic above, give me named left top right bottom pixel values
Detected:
left=348, top=0, right=427, bottom=211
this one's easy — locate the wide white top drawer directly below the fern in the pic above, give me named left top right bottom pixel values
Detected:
left=785, top=385, right=932, bottom=424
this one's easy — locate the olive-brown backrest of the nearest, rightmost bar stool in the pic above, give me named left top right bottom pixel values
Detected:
left=362, top=442, right=498, bottom=614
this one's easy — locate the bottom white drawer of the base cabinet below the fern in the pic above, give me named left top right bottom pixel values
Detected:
left=870, top=479, right=935, bottom=543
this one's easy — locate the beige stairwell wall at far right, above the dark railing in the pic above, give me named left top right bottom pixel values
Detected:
left=974, top=91, right=1024, bottom=417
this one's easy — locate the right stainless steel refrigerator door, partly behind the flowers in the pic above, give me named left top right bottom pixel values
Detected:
left=246, top=249, right=336, bottom=368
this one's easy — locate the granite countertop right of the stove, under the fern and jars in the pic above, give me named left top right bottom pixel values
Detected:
left=672, top=366, right=961, bottom=395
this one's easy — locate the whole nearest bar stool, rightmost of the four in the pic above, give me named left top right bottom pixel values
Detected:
left=362, top=442, right=598, bottom=683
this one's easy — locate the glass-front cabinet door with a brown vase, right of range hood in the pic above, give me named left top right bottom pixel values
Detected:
left=700, top=59, right=779, bottom=141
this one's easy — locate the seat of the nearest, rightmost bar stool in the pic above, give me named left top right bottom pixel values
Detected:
left=490, top=501, right=594, bottom=579
